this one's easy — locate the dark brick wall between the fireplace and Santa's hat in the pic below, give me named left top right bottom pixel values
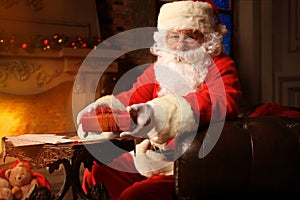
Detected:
left=96, top=0, right=156, bottom=74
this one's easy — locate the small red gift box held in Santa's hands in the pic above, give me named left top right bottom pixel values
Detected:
left=81, top=107, right=130, bottom=132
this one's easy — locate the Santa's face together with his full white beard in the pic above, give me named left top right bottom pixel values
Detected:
left=153, top=30, right=211, bottom=96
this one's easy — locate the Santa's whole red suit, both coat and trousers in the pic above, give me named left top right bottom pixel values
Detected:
left=83, top=54, right=241, bottom=199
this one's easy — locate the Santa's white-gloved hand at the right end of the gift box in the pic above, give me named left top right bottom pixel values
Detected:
left=120, top=103, right=154, bottom=138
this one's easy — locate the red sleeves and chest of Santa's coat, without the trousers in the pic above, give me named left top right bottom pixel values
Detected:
left=115, top=54, right=241, bottom=126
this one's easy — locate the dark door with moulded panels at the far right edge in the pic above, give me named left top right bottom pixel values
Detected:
left=272, top=0, right=300, bottom=107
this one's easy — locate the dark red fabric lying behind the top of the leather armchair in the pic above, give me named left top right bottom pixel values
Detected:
left=249, top=103, right=300, bottom=117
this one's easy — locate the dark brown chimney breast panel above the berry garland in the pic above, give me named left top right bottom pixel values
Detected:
left=0, top=0, right=100, bottom=37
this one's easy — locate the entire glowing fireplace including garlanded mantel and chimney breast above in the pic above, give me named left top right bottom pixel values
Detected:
left=0, top=0, right=118, bottom=152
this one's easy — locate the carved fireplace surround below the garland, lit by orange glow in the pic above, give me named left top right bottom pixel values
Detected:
left=0, top=48, right=118, bottom=150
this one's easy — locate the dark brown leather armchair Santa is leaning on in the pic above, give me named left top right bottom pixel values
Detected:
left=175, top=116, right=300, bottom=199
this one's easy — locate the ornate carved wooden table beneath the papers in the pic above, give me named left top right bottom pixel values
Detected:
left=2, top=133, right=133, bottom=200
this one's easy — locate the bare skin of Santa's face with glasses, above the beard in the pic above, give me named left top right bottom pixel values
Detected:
left=166, top=30, right=203, bottom=51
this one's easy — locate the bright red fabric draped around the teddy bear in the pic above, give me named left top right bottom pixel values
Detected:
left=0, top=159, right=51, bottom=190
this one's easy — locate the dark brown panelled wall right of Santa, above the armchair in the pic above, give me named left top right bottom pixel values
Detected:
left=235, top=0, right=300, bottom=107
